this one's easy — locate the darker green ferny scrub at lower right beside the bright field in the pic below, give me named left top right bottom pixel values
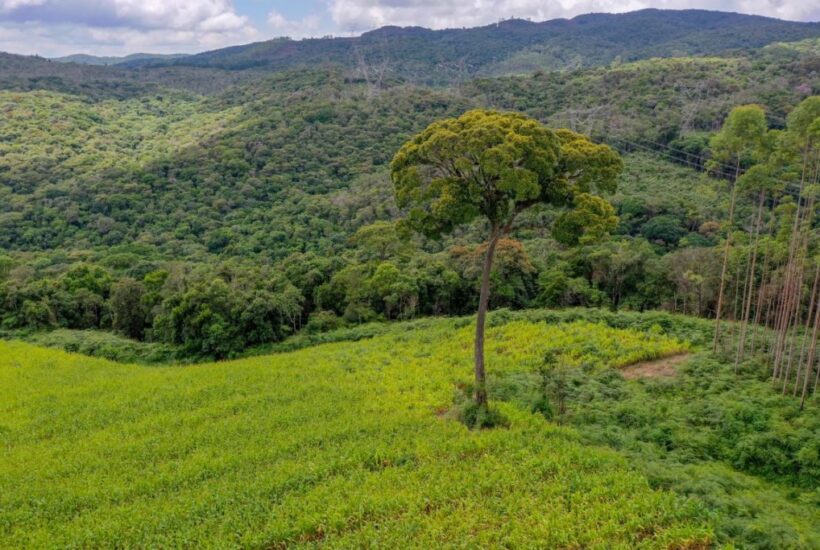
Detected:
left=490, top=352, right=820, bottom=549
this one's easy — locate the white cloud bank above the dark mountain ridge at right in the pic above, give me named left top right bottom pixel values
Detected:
left=330, top=0, right=820, bottom=31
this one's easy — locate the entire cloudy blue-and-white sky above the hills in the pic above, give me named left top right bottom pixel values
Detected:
left=0, top=0, right=820, bottom=57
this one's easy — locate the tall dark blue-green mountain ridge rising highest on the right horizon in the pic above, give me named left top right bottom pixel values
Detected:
left=123, top=9, right=820, bottom=84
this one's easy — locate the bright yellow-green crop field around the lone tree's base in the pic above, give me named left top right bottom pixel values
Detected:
left=0, top=319, right=712, bottom=548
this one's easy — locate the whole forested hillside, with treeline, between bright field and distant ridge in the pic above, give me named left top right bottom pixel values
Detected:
left=0, top=29, right=820, bottom=356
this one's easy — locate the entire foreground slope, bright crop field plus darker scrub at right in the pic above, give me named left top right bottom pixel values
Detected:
left=0, top=309, right=820, bottom=549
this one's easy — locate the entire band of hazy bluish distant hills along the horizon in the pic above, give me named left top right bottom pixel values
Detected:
left=0, top=10, right=820, bottom=99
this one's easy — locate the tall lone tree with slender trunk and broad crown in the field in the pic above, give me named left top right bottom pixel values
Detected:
left=390, top=110, right=623, bottom=407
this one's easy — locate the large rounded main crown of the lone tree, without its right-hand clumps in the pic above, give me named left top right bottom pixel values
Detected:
left=391, top=110, right=556, bottom=237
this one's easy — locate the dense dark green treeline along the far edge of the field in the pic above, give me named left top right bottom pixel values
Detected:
left=0, top=222, right=720, bottom=358
